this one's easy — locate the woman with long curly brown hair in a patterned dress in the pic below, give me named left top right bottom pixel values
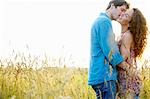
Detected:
left=117, top=8, right=148, bottom=99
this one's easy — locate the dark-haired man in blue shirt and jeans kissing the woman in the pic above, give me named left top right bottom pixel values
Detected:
left=88, top=0, right=129, bottom=99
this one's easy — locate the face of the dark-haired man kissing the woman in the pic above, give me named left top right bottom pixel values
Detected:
left=112, top=5, right=127, bottom=20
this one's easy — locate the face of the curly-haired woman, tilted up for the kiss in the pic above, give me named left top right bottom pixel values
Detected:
left=117, top=9, right=134, bottom=25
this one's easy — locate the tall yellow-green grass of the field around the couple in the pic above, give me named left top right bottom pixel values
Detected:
left=0, top=54, right=150, bottom=99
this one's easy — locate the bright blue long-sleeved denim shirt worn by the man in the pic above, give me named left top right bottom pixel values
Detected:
left=88, top=13, right=124, bottom=85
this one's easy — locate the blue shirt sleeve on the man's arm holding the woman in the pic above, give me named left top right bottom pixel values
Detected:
left=97, top=21, right=124, bottom=67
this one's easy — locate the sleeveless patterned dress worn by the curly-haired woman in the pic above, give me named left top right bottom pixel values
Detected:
left=118, top=33, right=141, bottom=97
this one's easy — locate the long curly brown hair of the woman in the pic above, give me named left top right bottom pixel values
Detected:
left=129, top=8, right=148, bottom=57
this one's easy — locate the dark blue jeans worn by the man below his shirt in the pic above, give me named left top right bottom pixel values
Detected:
left=92, top=81, right=116, bottom=99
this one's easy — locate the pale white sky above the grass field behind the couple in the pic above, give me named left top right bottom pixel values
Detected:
left=0, top=0, right=150, bottom=67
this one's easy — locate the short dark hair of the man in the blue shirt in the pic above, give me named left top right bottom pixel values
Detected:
left=106, top=0, right=129, bottom=10
